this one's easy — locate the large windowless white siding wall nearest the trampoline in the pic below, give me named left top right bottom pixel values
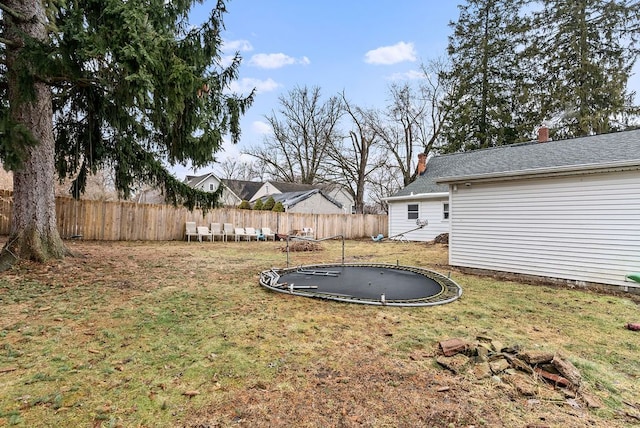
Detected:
left=449, top=171, right=640, bottom=287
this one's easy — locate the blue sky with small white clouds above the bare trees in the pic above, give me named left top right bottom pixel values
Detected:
left=174, top=0, right=461, bottom=179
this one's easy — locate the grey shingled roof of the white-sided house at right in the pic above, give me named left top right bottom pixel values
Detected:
left=392, top=129, right=640, bottom=197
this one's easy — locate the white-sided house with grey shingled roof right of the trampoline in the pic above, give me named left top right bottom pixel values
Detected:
left=388, top=128, right=640, bottom=287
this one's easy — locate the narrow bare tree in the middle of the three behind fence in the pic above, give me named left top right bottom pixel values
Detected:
left=327, top=92, right=384, bottom=214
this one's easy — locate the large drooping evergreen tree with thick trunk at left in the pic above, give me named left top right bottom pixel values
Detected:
left=0, top=0, right=253, bottom=261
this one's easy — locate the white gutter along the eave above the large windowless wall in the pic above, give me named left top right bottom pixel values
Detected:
left=436, top=159, right=640, bottom=184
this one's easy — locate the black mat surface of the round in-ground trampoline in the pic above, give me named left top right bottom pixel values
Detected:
left=280, top=266, right=443, bottom=301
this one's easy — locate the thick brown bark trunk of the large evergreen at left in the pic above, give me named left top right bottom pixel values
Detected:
left=0, top=0, right=66, bottom=270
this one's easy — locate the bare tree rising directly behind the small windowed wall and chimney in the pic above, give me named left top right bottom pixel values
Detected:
left=371, top=60, right=449, bottom=186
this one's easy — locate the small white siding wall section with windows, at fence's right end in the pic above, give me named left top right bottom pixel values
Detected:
left=387, top=195, right=449, bottom=242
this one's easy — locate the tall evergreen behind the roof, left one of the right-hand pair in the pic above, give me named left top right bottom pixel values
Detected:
left=442, top=0, right=529, bottom=152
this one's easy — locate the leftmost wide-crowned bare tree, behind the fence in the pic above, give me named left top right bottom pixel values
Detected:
left=247, top=87, right=343, bottom=184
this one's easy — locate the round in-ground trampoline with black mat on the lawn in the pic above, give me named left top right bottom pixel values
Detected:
left=260, top=263, right=462, bottom=306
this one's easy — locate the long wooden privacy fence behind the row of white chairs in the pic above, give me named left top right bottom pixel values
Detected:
left=0, top=191, right=388, bottom=241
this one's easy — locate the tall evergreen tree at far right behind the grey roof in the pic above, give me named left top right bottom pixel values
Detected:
left=529, top=0, right=640, bottom=138
